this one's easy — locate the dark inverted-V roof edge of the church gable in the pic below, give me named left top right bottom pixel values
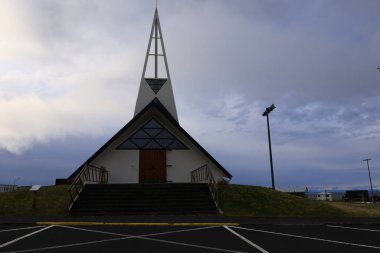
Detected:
left=68, top=98, right=232, bottom=179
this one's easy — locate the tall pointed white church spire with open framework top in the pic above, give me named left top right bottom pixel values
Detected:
left=135, top=8, right=178, bottom=121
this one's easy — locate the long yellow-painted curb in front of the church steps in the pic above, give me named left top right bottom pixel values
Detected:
left=37, top=221, right=239, bottom=227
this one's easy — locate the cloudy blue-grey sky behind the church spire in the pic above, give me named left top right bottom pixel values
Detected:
left=0, top=0, right=380, bottom=189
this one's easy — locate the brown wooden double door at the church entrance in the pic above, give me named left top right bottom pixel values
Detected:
left=139, top=149, right=166, bottom=183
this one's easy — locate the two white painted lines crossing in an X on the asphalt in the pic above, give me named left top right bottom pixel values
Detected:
left=3, top=226, right=243, bottom=253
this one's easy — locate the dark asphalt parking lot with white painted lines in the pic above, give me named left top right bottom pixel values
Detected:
left=0, top=223, right=380, bottom=253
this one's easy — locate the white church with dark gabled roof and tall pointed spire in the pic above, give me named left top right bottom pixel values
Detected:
left=68, top=6, right=232, bottom=184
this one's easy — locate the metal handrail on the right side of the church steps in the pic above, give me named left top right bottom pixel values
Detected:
left=191, top=164, right=222, bottom=213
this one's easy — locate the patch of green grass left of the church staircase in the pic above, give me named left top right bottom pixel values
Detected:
left=0, top=185, right=69, bottom=216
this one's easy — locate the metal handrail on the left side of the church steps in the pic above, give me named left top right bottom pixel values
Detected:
left=67, top=164, right=108, bottom=211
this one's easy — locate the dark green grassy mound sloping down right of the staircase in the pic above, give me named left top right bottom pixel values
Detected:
left=219, top=185, right=349, bottom=217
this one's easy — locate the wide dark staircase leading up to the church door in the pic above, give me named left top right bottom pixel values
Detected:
left=69, top=183, right=217, bottom=216
